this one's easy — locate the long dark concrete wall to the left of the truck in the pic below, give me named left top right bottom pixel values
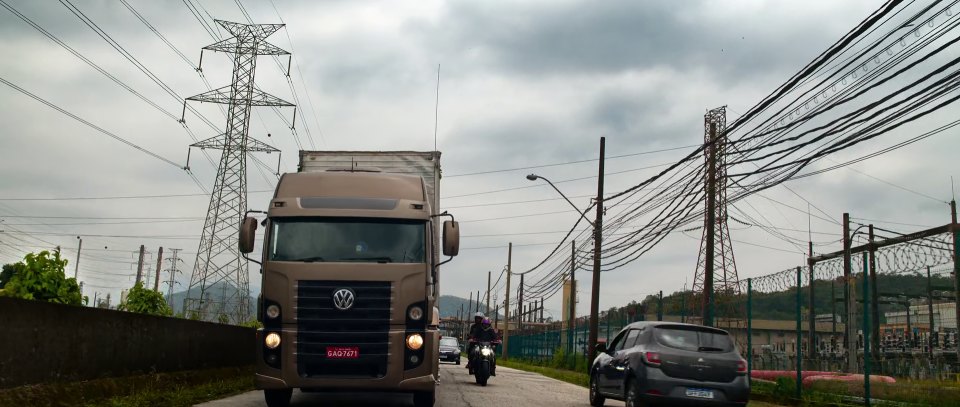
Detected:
left=0, top=297, right=256, bottom=388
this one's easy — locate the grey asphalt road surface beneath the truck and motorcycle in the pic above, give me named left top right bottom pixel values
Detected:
left=200, top=364, right=588, bottom=407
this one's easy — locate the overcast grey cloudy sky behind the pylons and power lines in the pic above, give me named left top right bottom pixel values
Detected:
left=0, top=0, right=960, bottom=317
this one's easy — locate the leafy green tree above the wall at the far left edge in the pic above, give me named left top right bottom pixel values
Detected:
left=3, top=250, right=84, bottom=305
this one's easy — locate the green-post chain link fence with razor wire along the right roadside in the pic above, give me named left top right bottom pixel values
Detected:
left=508, top=225, right=960, bottom=406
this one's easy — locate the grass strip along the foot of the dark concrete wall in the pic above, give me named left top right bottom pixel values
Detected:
left=0, top=367, right=254, bottom=407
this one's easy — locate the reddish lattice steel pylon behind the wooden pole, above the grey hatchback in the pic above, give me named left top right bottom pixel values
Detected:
left=693, top=107, right=740, bottom=325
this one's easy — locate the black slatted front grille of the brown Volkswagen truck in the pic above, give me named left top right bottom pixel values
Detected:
left=297, top=280, right=393, bottom=378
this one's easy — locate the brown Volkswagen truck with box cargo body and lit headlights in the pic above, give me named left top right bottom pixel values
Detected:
left=240, top=151, right=460, bottom=407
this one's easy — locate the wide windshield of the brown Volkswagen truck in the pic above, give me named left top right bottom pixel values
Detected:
left=269, top=218, right=427, bottom=263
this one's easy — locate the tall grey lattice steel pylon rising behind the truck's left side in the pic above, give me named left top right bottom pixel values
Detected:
left=184, top=20, right=293, bottom=323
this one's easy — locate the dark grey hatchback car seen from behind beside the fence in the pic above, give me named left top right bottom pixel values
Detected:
left=590, top=322, right=750, bottom=407
